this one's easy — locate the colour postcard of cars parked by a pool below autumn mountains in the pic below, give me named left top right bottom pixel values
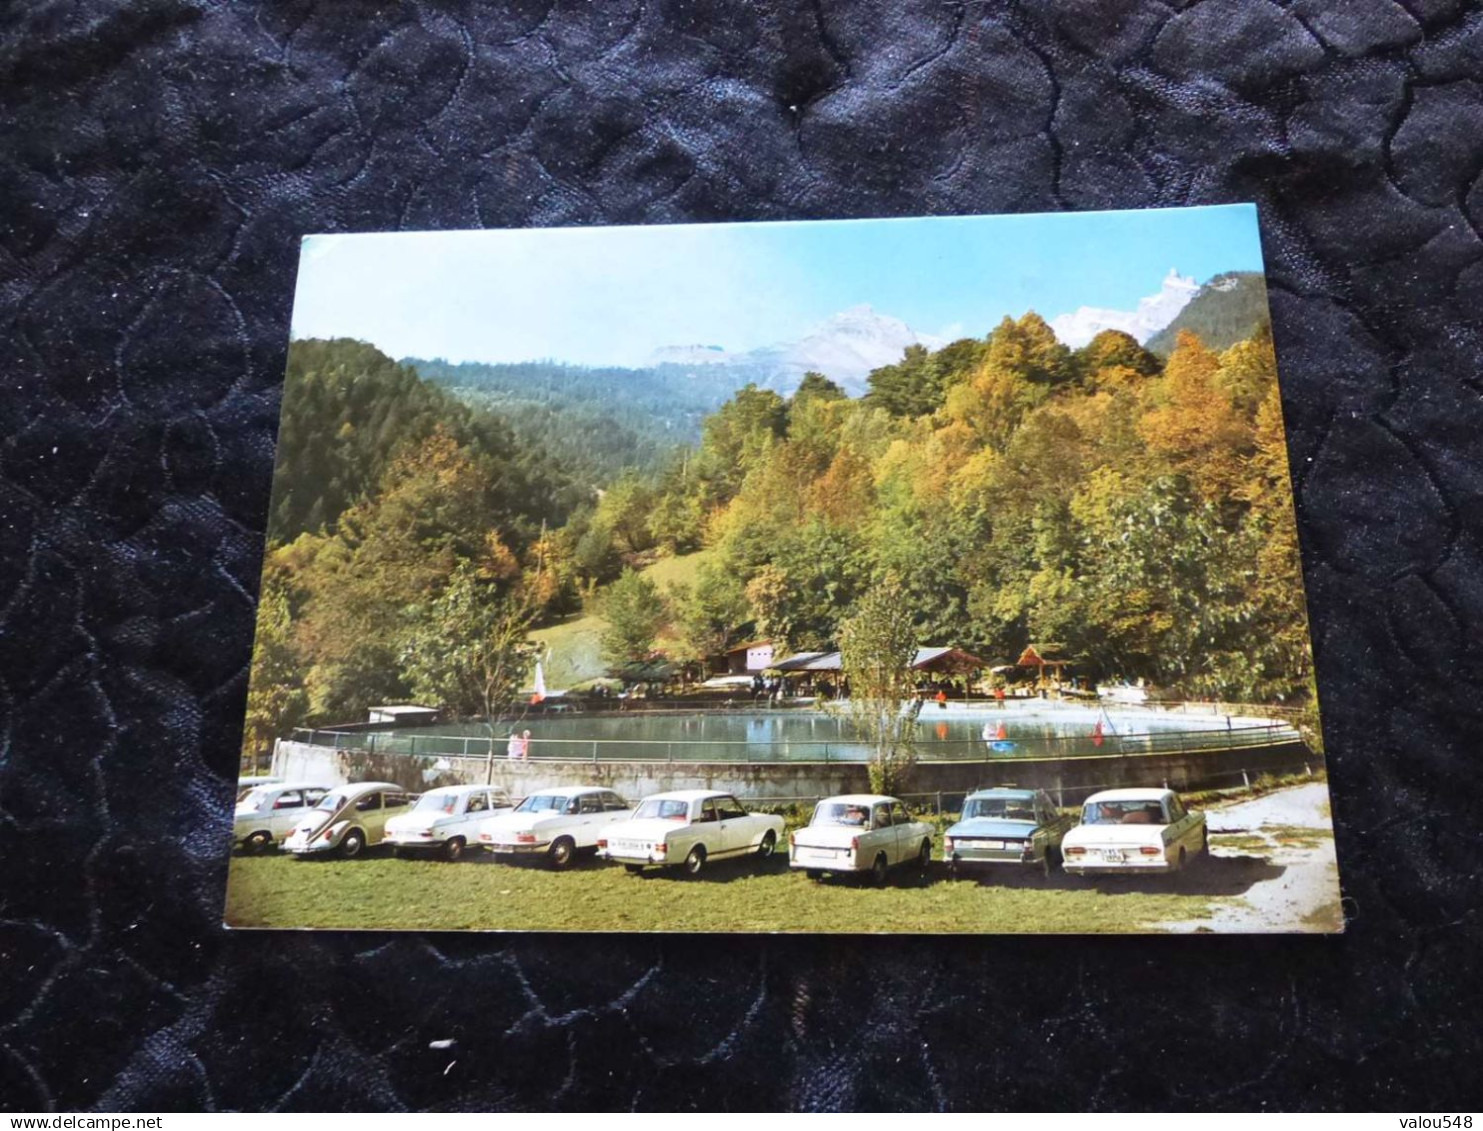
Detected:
left=225, top=205, right=1344, bottom=934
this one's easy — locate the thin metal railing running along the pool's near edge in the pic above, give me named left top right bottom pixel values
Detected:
left=292, top=722, right=1299, bottom=763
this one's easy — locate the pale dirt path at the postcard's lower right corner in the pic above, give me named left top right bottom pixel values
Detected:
left=1164, top=781, right=1344, bottom=934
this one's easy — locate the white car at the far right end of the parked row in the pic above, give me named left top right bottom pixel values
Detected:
left=1060, top=789, right=1206, bottom=876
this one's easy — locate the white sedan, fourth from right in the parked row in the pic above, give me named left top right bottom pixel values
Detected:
left=598, top=790, right=783, bottom=876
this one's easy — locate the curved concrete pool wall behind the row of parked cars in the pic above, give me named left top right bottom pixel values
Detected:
left=273, top=737, right=1323, bottom=805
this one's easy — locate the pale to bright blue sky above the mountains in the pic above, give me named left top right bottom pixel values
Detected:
left=294, top=205, right=1262, bottom=365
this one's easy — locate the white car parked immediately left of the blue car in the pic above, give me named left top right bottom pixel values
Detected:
left=789, top=793, right=933, bottom=883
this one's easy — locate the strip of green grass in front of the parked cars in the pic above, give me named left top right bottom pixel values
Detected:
left=216, top=845, right=1216, bottom=934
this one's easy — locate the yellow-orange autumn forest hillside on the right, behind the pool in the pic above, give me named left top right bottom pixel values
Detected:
left=566, top=313, right=1311, bottom=700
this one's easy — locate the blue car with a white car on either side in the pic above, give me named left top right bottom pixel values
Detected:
left=942, top=789, right=1077, bottom=876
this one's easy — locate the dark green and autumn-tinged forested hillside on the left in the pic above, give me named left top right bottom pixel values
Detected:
left=246, top=339, right=592, bottom=750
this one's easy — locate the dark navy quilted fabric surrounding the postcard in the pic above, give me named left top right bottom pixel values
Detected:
left=0, top=0, right=1483, bottom=1110
